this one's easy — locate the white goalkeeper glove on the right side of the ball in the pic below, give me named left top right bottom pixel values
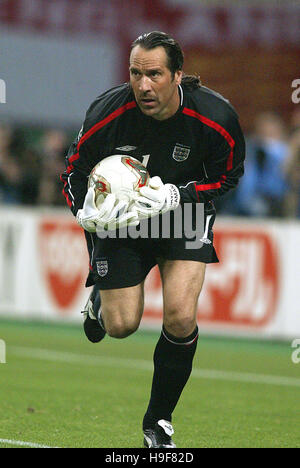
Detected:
left=131, top=176, right=180, bottom=219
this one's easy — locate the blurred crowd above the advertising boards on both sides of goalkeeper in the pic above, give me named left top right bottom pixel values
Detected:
left=0, top=108, right=300, bottom=219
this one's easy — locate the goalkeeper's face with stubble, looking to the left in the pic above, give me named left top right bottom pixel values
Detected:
left=129, top=45, right=182, bottom=120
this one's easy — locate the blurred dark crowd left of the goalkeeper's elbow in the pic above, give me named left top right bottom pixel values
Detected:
left=0, top=123, right=70, bottom=206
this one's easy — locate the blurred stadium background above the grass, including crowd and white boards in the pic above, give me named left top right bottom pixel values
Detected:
left=0, top=0, right=300, bottom=337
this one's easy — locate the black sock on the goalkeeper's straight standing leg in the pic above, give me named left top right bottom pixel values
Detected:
left=143, top=327, right=198, bottom=429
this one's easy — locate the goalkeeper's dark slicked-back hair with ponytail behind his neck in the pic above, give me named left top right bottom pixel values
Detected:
left=131, top=31, right=201, bottom=89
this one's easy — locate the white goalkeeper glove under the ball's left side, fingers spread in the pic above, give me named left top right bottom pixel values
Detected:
left=76, top=187, right=139, bottom=232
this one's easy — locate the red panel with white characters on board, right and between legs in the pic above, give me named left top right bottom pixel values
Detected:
left=144, top=227, right=279, bottom=328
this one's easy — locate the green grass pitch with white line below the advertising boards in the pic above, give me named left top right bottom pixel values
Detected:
left=0, top=319, right=300, bottom=448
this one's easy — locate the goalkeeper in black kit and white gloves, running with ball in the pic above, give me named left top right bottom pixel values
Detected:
left=61, top=31, right=245, bottom=448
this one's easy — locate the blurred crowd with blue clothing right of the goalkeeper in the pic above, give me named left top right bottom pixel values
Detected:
left=219, top=108, right=300, bottom=218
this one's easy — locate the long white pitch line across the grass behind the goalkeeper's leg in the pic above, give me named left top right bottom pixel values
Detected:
left=7, top=346, right=300, bottom=387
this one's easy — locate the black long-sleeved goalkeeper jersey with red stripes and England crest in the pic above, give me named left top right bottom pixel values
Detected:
left=61, top=83, right=245, bottom=215
